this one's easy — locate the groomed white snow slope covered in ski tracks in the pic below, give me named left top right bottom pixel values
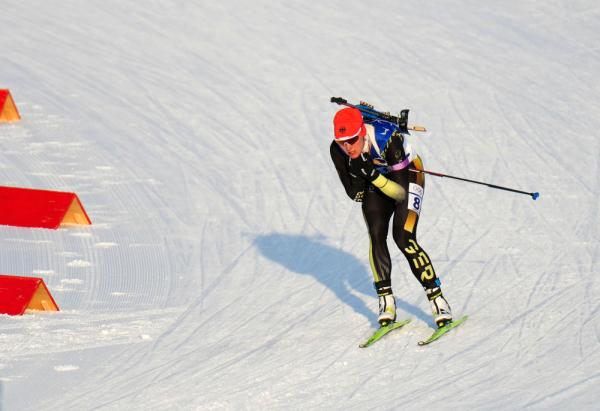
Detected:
left=0, top=0, right=600, bottom=410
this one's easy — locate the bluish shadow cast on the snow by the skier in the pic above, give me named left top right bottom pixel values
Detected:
left=254, top=233, right=430, bottom=325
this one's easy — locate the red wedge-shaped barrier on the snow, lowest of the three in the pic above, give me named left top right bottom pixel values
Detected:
left=0, top=275, right=59, bottom=315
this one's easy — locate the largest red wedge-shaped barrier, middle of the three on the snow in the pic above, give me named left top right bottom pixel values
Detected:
left=0, top=186, right=92, bottom=229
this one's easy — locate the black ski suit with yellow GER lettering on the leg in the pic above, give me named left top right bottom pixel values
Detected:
left=330, top=120, right=440, bottom=295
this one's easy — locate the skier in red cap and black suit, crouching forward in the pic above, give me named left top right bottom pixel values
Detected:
left=330, top=106, right=452, bottom=327
